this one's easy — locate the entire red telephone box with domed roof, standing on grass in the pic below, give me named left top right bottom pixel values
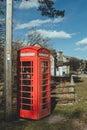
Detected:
left=19, top=46, right=51, bottom=120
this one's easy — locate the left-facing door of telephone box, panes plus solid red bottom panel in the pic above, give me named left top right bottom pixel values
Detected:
left=20, top=60, right=37, bottom=119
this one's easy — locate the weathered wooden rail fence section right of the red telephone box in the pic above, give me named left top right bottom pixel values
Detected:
left=51, top=82, right=76, bottom=104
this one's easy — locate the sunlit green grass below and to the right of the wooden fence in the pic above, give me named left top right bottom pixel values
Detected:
left=54, top=78, right=87, bottom=115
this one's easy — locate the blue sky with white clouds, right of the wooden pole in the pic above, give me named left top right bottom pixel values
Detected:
left=13, top=0, right=87, bottom=60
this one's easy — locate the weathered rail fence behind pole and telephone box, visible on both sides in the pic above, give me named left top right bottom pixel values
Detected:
left=0, top=82, right=76, bottom=108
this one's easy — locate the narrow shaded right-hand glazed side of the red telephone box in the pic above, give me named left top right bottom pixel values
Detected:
left=40, top=59, right=50, bottom=116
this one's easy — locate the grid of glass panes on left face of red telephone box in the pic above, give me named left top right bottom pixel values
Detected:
left=20, top=61, right=33, bottom=110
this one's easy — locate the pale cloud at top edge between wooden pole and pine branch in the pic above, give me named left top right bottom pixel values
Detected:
left=19, top=0, right=39, bottom=9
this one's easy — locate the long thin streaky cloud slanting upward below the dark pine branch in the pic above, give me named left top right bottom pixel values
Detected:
left=15, top=17, right=63, bottom=30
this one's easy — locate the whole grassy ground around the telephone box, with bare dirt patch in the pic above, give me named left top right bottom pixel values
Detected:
left=0, top=78, right=87, bottom=130
